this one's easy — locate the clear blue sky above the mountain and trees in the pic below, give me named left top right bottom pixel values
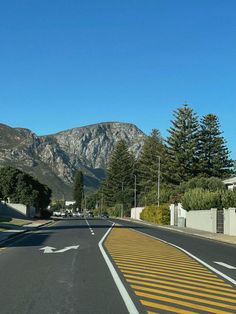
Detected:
left=0, top=0, right=236, bottom=159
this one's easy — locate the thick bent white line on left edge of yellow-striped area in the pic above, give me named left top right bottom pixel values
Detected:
left=98, top=223, right=139, bottom=314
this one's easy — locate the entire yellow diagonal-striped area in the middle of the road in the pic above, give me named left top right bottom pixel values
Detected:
left=105, top=228, right=236, bottom=314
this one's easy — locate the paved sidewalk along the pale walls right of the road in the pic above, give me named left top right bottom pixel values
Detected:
left=123, top=218, right=236, bottom=245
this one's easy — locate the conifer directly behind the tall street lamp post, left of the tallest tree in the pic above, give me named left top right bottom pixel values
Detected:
left=137, top=129, right=166, bottom=200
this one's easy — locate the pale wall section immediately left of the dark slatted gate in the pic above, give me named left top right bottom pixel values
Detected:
left=186, top=208, right=217, bottom=233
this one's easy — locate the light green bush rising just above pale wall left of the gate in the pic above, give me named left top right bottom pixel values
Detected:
left=181, top=188, right=223, bottom=211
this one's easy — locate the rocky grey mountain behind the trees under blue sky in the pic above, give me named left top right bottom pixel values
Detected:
left=0, top=122, right=145, bottom=199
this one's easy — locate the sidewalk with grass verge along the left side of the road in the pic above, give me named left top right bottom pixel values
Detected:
left=0, top=220, right=53, bottom=244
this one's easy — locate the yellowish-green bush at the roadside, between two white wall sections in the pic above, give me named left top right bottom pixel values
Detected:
left=140, top=204, right=170, bottom=225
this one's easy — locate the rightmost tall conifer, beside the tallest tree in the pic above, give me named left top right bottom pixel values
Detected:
left=198, top=114, right=233, bottom=178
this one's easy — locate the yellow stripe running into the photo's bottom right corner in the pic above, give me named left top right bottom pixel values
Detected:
left=135, top=291, right=232, bottom=314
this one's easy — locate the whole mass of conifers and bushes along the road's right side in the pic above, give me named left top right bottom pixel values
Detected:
left=93, top=104, right=236, bottom=224
